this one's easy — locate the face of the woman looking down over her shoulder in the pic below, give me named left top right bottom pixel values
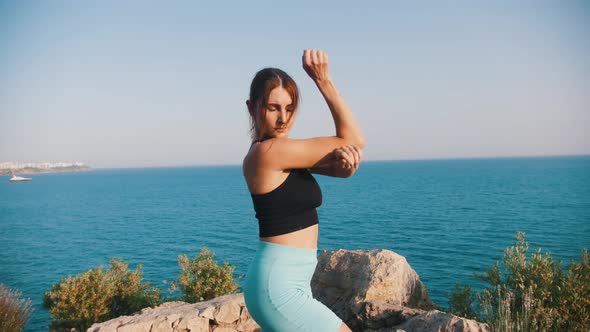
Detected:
left=257, top=86, right=295, bottom=138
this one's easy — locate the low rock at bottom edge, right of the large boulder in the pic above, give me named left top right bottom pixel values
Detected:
left=398, top=310, right=490, bottom=332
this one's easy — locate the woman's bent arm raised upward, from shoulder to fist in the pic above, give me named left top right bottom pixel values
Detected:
left=255, top=50, right=365, bottom=169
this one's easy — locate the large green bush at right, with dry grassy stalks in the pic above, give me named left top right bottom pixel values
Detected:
left=449, top=232, right=590, bottom=331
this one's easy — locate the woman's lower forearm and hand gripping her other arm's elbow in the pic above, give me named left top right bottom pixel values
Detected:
left=309, top=145, right=362, bottom=178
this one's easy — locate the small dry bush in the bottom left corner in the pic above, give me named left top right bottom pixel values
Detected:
left=0, top=283, right=33, bottom=332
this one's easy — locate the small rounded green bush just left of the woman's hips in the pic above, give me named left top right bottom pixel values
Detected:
left=170, top=247, right=238, bottom=303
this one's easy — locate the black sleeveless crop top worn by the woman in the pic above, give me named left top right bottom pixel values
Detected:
left=251, top=168, right=322, bottom=237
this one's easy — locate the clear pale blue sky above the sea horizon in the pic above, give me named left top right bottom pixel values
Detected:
left=0, top=0, right=590, bottom=168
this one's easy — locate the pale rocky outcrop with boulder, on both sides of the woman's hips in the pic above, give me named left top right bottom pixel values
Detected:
left=88, top=250, right=489, bottom=332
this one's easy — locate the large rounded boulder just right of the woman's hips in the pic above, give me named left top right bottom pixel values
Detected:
left=311, top=249, right=434, bottom=330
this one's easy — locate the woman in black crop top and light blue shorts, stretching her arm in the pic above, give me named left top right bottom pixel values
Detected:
left=243, top=50, right=364, bottom=332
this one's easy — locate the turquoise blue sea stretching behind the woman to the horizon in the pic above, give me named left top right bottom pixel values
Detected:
left=0, top=156, right=590, bottom=331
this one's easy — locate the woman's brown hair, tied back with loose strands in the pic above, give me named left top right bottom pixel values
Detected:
left=248, top=68, right=299, bottom=140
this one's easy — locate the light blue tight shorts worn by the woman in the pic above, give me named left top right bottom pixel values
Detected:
left=242, top=241, right=342, bottom=332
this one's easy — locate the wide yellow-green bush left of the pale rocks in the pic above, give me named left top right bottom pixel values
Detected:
left=43, top=258, right=162, bottom=331
